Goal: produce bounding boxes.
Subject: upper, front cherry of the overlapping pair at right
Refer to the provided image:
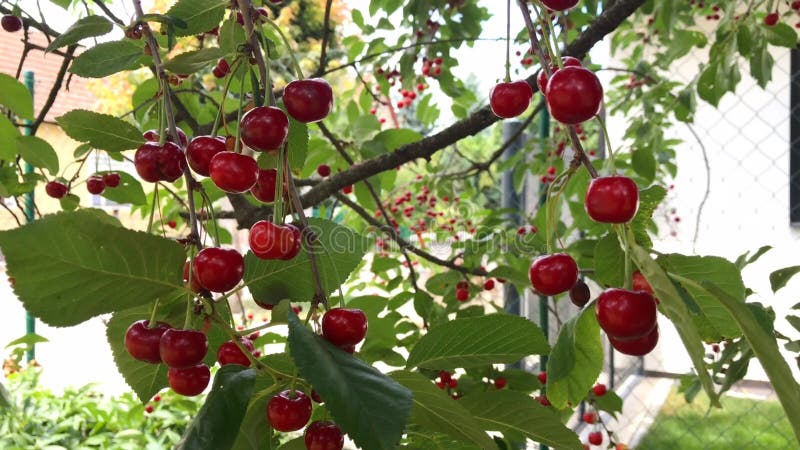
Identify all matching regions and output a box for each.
[595,288,657,340]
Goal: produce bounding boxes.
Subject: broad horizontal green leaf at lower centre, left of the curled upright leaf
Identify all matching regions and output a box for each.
[407,314,550,369]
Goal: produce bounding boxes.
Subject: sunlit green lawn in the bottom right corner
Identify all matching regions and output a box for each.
[636,390,800,450]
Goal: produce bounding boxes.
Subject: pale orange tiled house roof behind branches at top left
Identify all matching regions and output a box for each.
[0,29,97,122]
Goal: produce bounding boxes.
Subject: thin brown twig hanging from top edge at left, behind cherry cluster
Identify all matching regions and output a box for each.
[133,0,202,248]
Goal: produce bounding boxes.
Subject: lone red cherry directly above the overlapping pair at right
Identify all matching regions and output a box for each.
[585,176,639,223]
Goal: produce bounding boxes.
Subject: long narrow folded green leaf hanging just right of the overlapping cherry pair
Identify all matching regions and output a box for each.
[631,245,721,407]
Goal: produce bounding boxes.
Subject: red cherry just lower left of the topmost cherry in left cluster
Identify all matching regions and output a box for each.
[240,106,289,152]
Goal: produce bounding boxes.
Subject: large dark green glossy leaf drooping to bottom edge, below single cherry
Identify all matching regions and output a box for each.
[289,312,412,450]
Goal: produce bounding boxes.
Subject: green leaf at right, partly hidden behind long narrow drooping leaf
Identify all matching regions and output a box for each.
[658,254,745,341]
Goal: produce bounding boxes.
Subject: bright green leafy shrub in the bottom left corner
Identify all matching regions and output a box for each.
[0,369,203,450]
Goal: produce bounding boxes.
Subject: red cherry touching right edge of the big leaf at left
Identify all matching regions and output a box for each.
[192,247,244,292]
